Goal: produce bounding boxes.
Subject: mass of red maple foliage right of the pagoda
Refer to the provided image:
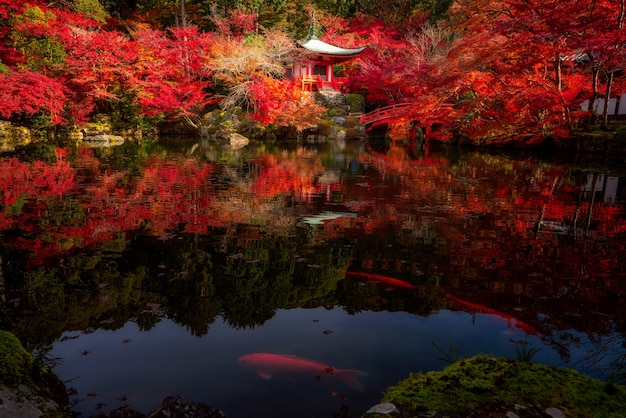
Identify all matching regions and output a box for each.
[325,0,624,143]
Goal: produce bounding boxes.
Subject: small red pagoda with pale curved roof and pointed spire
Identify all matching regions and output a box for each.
[291,10,367,91]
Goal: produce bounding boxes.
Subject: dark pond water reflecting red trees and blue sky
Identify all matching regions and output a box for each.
[0,139,626,418]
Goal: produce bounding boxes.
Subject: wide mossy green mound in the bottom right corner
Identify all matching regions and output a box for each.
[384,355,626,417]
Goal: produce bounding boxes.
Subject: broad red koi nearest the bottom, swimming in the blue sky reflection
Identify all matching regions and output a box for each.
[239,353,367,390]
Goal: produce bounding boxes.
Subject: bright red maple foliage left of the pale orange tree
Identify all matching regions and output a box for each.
[0,1,221,124]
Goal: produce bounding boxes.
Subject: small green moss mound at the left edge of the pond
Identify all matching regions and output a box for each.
[0,330,33,387]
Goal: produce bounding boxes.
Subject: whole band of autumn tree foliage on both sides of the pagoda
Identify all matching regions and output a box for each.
[0,0,626,143]
